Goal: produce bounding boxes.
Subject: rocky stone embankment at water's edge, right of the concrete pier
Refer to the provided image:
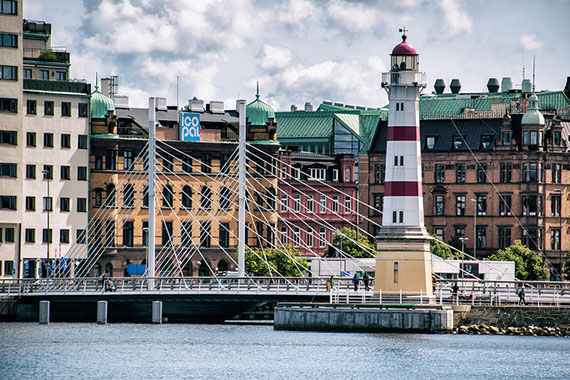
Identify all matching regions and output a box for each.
[457,306,570,328]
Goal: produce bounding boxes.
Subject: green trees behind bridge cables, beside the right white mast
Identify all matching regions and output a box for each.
[245,245,309,277]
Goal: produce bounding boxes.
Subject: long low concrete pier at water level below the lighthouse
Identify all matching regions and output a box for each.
[274,304,453,332]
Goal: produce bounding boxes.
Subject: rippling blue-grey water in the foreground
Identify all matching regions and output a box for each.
[0,323,570,380]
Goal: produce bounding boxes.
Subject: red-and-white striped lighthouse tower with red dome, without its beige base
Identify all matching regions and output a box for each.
[381,30,426,235]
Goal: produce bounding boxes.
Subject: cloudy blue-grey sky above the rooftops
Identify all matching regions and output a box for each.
[24,0,570,110]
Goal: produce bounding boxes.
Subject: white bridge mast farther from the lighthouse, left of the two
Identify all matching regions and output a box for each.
[143,98,156,290]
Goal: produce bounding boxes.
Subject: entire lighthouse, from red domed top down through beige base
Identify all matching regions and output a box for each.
[375,29,432,296]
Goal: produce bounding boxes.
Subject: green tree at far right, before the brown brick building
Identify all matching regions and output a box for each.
[487,240,548,281]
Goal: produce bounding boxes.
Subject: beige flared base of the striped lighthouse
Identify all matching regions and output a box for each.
[374,226,433,297]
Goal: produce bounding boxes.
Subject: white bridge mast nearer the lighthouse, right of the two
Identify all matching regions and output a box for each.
[236,99,247,277]
